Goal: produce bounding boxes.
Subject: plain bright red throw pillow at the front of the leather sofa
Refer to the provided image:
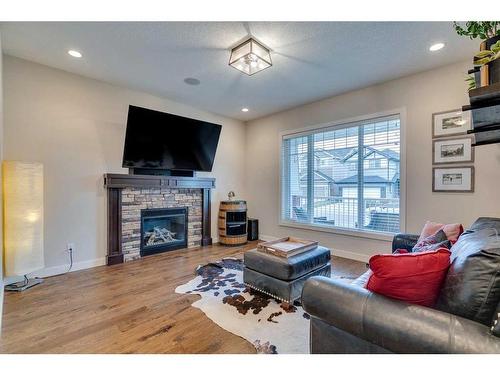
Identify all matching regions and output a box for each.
[366,248,451,307]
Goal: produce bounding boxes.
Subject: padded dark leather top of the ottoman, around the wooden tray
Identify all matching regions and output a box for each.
[243,246,330,280]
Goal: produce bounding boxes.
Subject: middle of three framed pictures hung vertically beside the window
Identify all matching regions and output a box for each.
[432,137,474,164]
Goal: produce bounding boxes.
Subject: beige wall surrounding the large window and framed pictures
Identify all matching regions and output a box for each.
[246,62,500,259]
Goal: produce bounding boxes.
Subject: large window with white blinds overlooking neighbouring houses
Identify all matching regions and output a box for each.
[281,115,401,233]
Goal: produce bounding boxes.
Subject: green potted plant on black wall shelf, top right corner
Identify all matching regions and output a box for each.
[453,21,500,87]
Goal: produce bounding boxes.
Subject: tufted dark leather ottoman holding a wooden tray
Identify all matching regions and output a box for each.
[243,246,331,303]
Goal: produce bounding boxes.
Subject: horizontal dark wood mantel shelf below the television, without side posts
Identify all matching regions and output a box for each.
[104,173,215,189]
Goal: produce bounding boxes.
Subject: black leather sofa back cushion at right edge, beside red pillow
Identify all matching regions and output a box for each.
[437,219,500,325]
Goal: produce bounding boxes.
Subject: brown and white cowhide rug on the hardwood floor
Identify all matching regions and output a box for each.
[175,258,352,354]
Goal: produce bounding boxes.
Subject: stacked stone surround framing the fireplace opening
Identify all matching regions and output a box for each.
[121,188,202,262]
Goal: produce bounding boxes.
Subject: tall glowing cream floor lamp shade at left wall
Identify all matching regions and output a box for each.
[3,161,44,276]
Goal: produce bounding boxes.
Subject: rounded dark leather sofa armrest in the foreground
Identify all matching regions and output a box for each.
[302,277,500,353]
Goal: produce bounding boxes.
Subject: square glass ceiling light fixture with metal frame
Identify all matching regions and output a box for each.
[229,38,273,76]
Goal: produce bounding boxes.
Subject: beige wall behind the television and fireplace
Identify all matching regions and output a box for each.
[4,56,245,274]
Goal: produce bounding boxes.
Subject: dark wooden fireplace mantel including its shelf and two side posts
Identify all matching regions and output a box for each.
[104,173,215,266]
